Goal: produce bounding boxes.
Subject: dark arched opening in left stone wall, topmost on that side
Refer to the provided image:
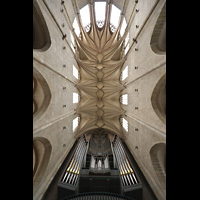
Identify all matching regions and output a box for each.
[33,1,51,51]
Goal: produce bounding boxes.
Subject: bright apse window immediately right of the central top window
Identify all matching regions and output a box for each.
[110,5,121,32]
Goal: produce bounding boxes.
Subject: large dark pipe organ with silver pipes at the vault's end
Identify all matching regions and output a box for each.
[58,129,142,200]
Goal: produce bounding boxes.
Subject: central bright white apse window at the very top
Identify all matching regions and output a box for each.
[94,2,106,28]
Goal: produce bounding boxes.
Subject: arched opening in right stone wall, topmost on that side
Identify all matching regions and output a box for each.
[150,4,166,54]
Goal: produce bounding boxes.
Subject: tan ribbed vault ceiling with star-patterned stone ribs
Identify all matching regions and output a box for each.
[73,1,130,135]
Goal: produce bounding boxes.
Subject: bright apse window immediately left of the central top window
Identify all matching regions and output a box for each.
[80,5,90,32]
